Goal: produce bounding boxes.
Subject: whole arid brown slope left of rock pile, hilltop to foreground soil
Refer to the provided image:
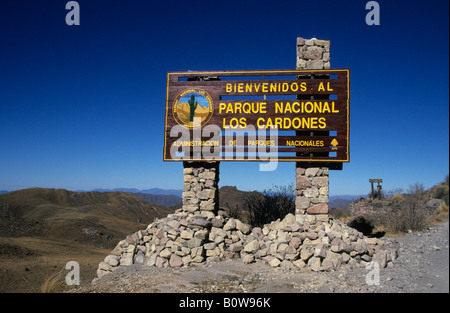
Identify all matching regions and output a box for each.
[0,188,172,292]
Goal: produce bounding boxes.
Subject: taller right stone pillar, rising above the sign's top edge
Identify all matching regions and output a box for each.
[295,37,330,220]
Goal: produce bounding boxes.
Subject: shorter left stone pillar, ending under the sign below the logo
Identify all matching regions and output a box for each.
[182,161,220,220]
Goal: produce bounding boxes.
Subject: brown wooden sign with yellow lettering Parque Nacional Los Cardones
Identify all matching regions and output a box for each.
[164,69,350,162]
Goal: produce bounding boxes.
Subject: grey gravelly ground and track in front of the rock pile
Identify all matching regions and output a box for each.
[72,221,449,293]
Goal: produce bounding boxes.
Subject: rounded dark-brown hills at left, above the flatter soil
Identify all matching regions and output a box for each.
[0,188,170,244]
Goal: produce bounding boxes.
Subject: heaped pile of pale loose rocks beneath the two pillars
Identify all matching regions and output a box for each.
[97,209,397,277]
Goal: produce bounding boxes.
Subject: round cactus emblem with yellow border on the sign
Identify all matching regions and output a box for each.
[173,88,214,128]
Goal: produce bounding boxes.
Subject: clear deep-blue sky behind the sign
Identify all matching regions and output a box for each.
[0,0,449,195]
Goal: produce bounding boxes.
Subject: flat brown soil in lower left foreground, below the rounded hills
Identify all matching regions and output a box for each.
[0,237,110,292]
